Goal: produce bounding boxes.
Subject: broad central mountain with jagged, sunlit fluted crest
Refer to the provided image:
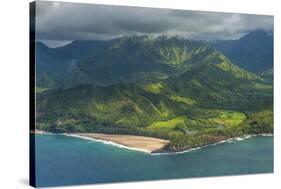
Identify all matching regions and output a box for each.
[62,36,214,87]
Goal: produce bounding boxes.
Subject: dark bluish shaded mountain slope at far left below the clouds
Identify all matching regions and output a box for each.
[35,41,110,89]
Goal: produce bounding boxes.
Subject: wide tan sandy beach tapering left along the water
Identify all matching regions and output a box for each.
[73,133,169,152]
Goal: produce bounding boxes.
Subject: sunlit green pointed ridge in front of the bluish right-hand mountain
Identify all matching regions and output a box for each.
[165,52,272,110]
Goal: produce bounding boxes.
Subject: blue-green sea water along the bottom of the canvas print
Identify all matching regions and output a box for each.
[35,135,273,187]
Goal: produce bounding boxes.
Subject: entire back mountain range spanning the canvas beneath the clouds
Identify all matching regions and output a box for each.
[36,30,273,88]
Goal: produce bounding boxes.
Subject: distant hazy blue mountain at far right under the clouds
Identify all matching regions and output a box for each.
[214,30,273,73]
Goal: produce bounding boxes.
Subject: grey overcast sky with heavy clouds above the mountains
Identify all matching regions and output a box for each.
[36,1,273,46]
